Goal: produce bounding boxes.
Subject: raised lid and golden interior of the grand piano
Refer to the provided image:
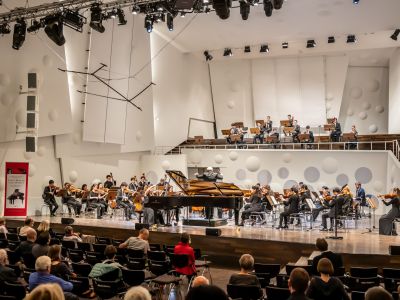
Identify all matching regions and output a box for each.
[165,170,243,196]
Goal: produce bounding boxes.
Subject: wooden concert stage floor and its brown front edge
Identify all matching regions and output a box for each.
[7,216,400,268]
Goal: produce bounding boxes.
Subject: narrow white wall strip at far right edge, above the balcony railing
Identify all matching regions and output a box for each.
[389,48,400,133]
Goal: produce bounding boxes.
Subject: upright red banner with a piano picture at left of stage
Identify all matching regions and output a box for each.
[4,162,29,217]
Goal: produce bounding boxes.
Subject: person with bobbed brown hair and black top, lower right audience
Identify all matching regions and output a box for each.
[307,258,350,300]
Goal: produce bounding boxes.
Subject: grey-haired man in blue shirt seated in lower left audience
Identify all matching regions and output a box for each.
[29,256,73,292]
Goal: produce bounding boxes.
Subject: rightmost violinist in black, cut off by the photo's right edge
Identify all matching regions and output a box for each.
[378,188,400,235]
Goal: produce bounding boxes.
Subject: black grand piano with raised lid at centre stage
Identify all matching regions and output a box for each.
[145,170,244,226]
